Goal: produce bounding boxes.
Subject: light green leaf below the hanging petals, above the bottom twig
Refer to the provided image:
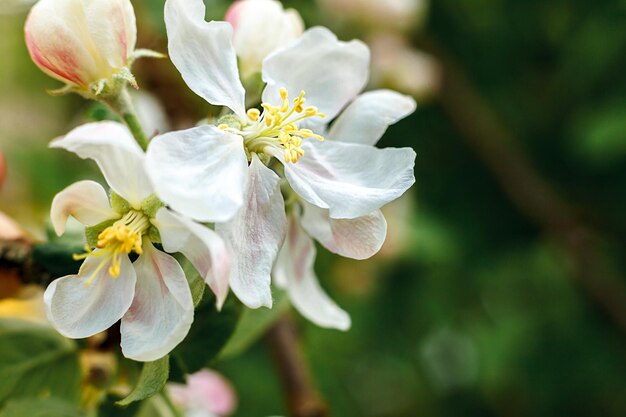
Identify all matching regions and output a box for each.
[219,291,289,359]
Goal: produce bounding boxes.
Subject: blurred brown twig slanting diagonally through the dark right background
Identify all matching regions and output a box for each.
[426,40,626,332]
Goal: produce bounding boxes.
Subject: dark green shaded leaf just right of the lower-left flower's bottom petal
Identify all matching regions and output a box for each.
[172,290,243,373]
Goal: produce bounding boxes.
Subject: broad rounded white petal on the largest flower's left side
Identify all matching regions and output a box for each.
[146,125,248,222]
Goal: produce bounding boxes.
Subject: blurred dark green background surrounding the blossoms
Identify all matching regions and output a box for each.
[0,0,626,417]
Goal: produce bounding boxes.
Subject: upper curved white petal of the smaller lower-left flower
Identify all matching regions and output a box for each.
[50,122,153,208]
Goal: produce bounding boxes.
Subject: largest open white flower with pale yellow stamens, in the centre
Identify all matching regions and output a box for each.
[147,0,415,328]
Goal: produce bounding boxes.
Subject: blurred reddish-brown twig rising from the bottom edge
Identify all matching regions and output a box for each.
[267,315,330,417]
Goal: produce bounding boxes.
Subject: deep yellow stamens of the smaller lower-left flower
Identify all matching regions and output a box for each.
[74,210,150,287]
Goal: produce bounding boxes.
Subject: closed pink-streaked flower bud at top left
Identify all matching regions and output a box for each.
[25,0,137,89]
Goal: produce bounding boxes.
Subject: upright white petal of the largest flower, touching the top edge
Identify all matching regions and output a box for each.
[165,0,245,115]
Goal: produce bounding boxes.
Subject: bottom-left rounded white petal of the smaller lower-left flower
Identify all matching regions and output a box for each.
[44,250,137,339]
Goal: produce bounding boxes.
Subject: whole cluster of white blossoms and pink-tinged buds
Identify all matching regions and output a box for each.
[26,0,416,361]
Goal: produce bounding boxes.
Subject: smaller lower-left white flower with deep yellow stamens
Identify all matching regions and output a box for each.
[44,122,229,361]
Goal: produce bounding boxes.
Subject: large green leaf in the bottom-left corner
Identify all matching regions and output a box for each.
[0,319,81,403]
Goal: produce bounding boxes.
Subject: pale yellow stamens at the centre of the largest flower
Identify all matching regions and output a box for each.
[218,88,326,163]
